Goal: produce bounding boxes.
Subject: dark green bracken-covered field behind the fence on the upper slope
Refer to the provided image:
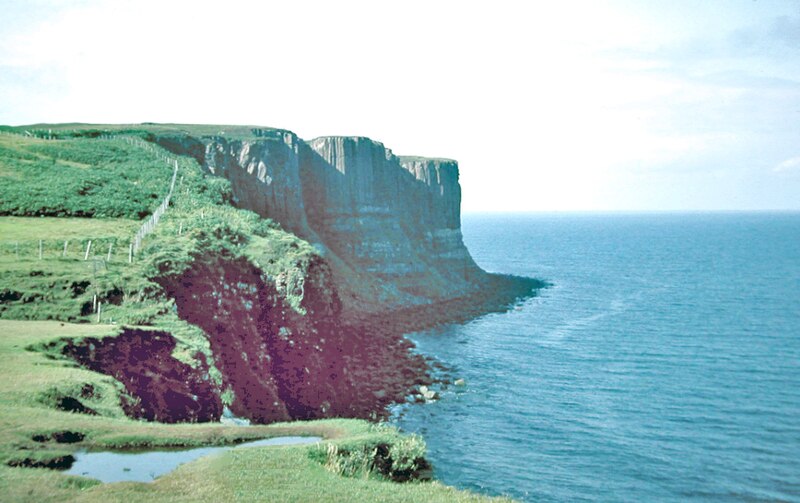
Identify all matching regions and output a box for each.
[0,134,178,219]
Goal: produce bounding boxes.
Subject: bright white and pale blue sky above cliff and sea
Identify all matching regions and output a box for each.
[0,0,800,212]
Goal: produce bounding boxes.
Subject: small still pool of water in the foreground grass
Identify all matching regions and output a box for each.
[64,437,322,482]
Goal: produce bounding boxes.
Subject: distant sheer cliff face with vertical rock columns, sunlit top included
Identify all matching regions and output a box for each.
[156,130,486,315]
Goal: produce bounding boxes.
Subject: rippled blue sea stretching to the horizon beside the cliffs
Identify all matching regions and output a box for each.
[395,213,800,501]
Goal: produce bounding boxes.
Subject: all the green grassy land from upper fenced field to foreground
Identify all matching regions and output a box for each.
[0,129,510,501]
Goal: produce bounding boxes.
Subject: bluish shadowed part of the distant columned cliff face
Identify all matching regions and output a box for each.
[299,138,486,316]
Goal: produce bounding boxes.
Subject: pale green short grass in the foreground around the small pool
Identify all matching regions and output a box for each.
[0,320,510,502]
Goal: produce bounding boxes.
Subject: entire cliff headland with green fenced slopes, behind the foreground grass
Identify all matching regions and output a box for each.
[0,125,542,423]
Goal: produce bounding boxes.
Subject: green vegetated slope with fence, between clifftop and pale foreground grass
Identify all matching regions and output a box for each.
[0,134,315,366]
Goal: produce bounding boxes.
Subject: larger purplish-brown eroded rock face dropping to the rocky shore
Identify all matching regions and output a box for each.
[155,257,432,423]
